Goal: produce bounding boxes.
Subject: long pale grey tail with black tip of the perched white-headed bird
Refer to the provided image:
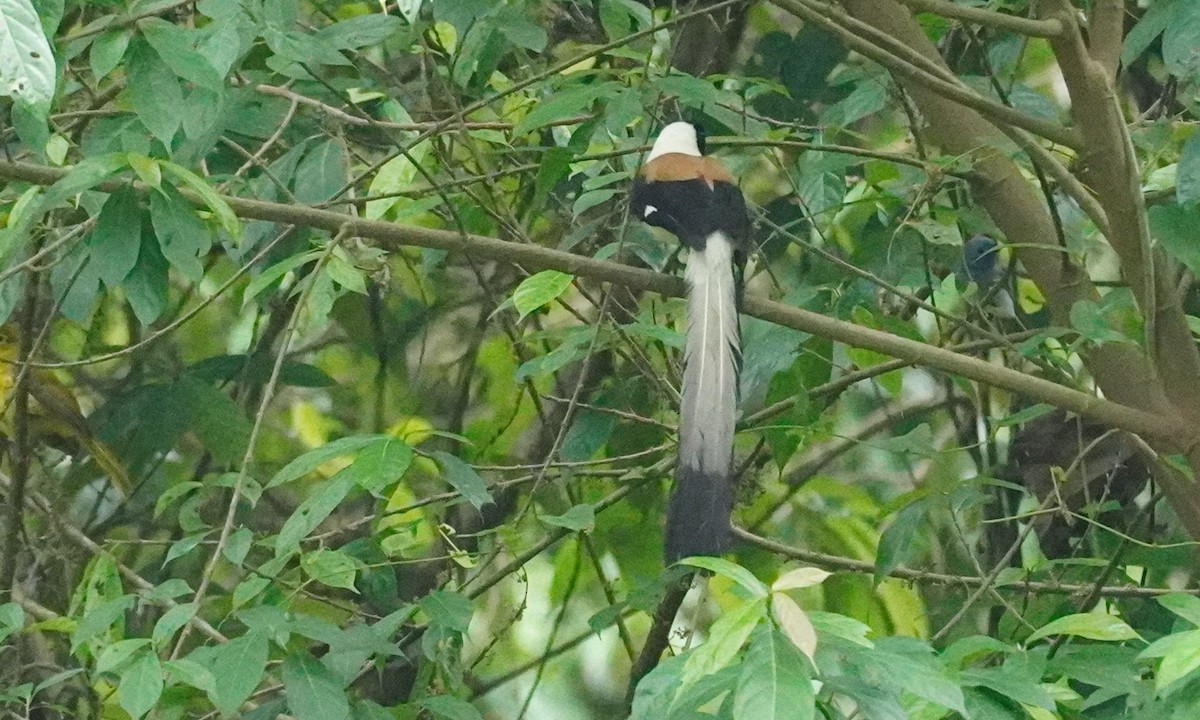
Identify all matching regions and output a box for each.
[665,233,740,562]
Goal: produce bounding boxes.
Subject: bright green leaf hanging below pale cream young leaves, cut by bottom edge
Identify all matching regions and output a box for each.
[733,625,816,720]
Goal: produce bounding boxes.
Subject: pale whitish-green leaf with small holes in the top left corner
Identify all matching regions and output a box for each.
[0,0,58,104]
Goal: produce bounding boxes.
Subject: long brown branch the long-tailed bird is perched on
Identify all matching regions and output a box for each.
[0,162,1193,448]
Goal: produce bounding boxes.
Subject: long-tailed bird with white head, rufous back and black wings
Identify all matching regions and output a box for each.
[630,121,750,563]
